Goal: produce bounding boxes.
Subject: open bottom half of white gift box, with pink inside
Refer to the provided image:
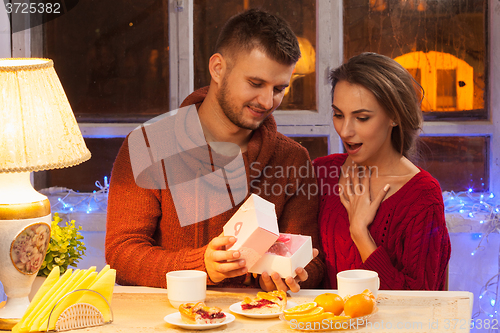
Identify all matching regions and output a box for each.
[249,234,313,278]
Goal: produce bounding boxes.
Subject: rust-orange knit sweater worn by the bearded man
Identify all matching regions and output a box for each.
[106,89,324,288]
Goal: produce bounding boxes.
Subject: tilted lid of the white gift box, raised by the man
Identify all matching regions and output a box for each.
[224,194,279,268]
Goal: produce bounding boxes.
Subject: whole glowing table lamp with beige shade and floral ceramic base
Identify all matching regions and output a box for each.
[0,58,90,329]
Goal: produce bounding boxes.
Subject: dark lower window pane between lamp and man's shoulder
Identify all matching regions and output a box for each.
[35,138,125,192]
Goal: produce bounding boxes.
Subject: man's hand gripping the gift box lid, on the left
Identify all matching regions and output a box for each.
[205,234,248,283]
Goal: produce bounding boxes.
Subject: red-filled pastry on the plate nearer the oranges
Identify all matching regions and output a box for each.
[241,290,286,314]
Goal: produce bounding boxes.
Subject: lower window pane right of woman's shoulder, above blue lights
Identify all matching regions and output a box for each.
[417,136,489,192]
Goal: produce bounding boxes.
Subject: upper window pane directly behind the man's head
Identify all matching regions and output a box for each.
[194,0,316,110]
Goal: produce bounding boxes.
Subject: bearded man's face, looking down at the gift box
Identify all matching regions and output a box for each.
[216,49,295,130]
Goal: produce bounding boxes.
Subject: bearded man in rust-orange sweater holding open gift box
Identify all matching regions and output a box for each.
[106,9,324,292]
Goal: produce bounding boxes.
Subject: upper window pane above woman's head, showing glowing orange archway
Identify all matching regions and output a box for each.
[344,0,487,120]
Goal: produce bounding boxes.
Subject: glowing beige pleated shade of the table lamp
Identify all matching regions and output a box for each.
[0,58,90,172]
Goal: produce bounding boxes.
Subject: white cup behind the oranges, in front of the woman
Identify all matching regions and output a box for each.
[337,269,380,298]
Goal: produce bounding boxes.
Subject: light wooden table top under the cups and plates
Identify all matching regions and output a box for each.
[72,286,473,333]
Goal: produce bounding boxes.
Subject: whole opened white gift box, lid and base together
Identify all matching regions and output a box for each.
[224,194,313,278]
